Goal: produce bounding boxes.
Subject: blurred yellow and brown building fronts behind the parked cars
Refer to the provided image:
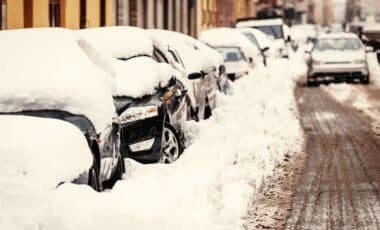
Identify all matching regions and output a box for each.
[0,0,257,36]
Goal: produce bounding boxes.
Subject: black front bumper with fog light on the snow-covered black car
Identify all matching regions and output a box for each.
[120,116,163,163]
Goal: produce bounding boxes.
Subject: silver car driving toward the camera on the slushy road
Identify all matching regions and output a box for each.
[307,33,370,85]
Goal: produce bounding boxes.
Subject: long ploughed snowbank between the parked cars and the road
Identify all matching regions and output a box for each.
[0,53,305,230]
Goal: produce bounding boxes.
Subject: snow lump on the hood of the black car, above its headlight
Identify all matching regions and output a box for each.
[114,56,180,98]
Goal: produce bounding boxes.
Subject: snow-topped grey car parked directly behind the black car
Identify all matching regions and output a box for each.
[149,30,221,119]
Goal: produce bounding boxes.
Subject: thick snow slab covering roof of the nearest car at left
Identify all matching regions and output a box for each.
[0,28,115,131]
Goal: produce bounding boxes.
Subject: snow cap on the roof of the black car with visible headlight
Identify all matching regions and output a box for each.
[77,26,153,58]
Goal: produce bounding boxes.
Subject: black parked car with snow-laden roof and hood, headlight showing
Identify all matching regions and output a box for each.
[77,27,188,163]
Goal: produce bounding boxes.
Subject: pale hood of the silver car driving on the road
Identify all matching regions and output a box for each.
[311,50,366,62]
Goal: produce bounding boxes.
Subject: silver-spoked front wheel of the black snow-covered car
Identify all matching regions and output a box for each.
[159,124,182,164]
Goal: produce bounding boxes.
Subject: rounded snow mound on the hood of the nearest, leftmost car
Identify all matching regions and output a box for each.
[0,115,92,191]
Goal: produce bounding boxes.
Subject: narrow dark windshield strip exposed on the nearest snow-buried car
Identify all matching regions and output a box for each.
[0,110,96,136]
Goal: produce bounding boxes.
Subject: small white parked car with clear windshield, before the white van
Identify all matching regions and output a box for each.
[214,46,250,81]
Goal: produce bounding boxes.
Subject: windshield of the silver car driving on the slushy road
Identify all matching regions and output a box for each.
[314,38,362,51]
